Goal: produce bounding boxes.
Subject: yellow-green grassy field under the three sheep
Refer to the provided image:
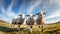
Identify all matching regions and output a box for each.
[0,21,60,34]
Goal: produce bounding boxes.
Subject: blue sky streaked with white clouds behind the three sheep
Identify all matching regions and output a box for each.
[0,0,60,24]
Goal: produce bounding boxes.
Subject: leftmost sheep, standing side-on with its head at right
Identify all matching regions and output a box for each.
[11,15,25,30]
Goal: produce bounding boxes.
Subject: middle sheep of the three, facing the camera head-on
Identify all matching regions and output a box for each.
[26,14,35,33]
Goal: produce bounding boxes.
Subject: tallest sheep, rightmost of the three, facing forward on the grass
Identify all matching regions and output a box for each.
[36,11,45,31]
